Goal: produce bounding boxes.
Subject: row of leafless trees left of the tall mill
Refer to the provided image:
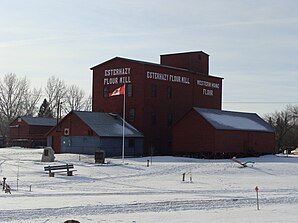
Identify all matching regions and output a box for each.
[0,74,91,144]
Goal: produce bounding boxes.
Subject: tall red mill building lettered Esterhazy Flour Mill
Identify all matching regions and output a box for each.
[91,51,222,155]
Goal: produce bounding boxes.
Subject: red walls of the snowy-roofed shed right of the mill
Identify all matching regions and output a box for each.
[173,109,274,158]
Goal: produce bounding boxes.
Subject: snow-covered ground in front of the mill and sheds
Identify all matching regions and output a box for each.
[0,148,298,223]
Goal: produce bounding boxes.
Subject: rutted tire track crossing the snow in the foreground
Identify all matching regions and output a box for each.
[0,197,298,222]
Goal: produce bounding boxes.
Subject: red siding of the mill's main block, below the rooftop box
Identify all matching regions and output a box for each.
[92,54,222,155]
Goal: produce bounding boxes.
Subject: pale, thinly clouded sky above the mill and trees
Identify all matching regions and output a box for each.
[0,0,298,115]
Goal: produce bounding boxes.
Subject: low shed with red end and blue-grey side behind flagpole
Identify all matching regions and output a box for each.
[47,111,144,157]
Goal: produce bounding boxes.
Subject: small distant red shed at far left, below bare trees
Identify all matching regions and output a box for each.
[9,116,57,147]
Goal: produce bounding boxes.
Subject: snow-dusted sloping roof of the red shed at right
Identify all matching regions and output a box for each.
[194,108,274,132]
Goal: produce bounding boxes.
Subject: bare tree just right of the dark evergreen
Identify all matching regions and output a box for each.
[45,76,67,117]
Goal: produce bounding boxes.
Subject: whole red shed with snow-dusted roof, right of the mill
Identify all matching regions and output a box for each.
[173,108,275,158]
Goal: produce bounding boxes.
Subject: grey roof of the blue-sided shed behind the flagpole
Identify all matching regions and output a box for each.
[73,111,144,137]
